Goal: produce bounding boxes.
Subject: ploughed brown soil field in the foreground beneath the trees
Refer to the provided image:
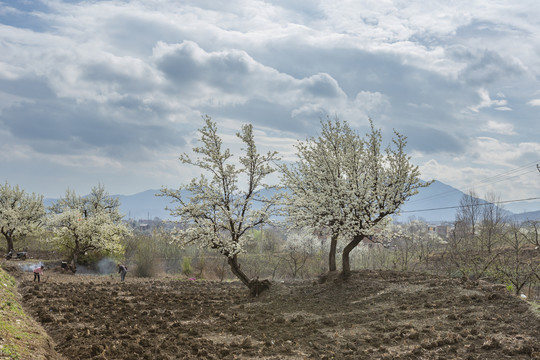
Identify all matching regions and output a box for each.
[8,271,540,360]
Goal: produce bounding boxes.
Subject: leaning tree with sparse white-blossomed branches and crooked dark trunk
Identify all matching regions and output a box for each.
[161,116,279,294]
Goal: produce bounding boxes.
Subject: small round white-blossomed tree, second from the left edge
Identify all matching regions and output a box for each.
[49,185,130,272]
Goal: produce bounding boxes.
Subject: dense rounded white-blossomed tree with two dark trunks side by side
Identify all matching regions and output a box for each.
[282,118,429,278]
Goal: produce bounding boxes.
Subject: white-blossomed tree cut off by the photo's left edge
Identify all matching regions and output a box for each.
[0,182,45,252]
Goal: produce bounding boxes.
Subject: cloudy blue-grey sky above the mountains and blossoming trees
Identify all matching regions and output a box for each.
[0,0,540,212]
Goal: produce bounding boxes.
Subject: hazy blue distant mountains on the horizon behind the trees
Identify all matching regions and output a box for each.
[44,181,540,223]
